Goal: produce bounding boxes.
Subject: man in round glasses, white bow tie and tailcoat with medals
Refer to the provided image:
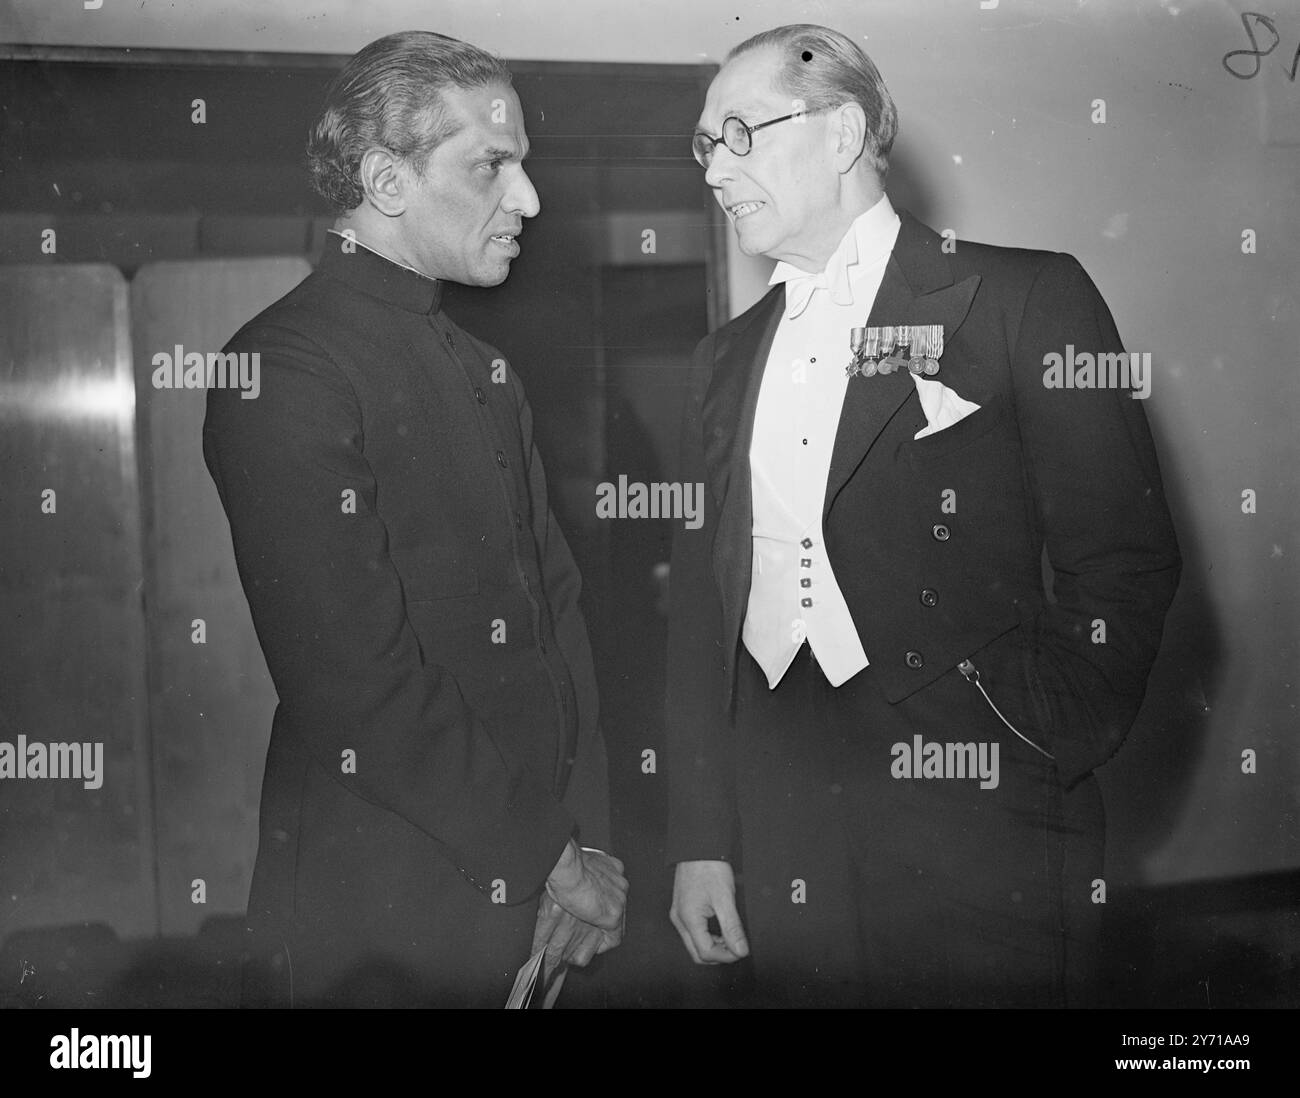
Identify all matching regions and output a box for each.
[667,25,1180,1007]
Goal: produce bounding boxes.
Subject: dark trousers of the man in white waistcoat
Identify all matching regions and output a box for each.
[736,645,1104,1007]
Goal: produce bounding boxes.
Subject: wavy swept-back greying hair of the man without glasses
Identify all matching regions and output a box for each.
[307,30,511,211]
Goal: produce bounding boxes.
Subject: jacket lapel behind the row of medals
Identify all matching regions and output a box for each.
[822,211,980,525]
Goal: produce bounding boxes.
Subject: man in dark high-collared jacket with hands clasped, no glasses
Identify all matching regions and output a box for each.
[203,31,627,1007]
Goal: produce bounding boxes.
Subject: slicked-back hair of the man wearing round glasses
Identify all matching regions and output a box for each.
[727,23,898,178]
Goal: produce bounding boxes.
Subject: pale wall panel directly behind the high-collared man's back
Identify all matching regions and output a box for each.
[131,259,311,934]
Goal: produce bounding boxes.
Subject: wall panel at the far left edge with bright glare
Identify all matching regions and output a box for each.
[0,265,157,941]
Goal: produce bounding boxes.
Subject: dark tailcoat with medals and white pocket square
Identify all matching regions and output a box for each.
[667,213,1180,862]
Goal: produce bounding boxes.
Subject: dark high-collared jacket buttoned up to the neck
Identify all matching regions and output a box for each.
[203,236,608,1002]
